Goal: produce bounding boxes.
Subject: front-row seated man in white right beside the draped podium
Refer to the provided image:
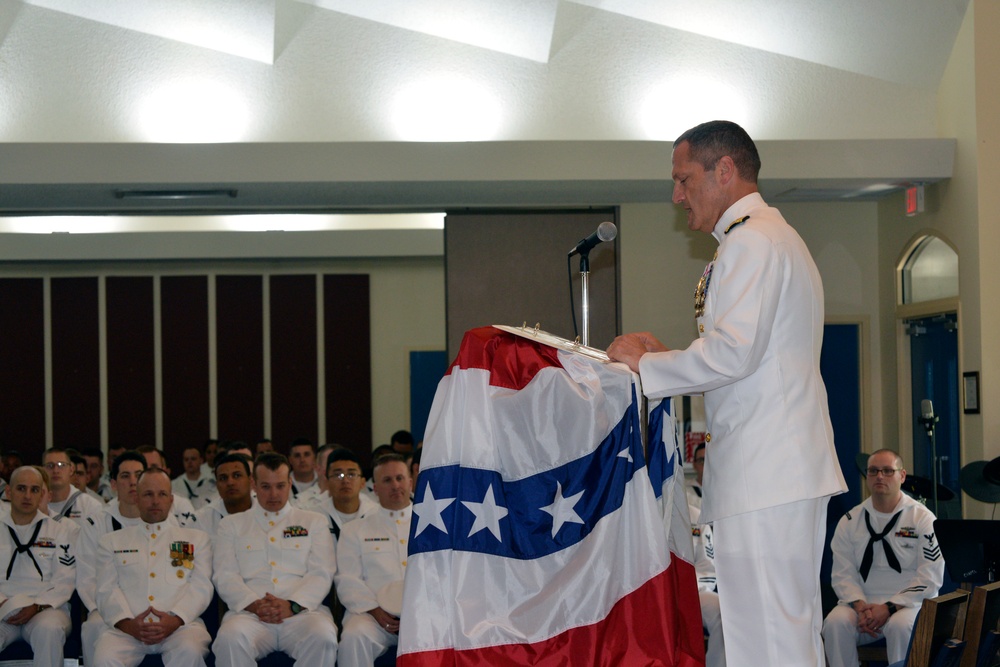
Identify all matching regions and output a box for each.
[336,454,413,667]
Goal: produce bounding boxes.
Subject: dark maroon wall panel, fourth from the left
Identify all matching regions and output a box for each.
[160,275,211,476]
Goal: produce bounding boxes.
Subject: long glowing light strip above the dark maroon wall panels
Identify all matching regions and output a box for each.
[0,213,445,234]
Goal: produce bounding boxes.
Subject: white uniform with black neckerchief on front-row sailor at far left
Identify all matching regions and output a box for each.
[0,512,80,666]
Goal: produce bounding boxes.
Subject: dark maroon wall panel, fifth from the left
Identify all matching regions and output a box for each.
[215,275,268,442]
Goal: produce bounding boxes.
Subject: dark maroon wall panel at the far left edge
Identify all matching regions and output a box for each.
[0,278,45,461]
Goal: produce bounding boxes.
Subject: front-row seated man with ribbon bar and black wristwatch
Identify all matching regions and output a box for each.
[212,453,337,667]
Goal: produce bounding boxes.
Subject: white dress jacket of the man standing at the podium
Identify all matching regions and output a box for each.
[639,193,847,523]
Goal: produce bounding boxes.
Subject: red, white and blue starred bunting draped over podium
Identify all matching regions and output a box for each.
[397,327,704,667]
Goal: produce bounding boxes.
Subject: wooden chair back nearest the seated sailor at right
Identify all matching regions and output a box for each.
[893,590,969,667]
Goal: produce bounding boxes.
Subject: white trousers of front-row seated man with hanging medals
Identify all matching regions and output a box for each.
[92,619,212,667]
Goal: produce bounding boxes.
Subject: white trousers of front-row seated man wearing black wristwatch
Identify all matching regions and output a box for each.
[212,607,337,667]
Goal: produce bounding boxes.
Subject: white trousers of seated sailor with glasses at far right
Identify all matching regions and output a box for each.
[823,604,920,667]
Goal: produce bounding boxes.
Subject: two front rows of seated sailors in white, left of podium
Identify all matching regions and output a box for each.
[0,448,413,667]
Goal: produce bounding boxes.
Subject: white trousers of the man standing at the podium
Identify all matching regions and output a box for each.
[714,497,829,667]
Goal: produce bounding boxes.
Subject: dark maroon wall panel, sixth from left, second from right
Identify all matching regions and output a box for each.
[270,274,322,451]
